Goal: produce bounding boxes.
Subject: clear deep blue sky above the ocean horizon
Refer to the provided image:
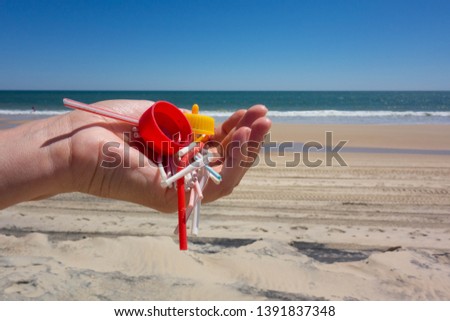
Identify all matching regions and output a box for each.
[0,0,450,90]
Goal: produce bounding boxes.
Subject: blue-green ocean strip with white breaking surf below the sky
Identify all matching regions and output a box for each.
[0,91,450,124]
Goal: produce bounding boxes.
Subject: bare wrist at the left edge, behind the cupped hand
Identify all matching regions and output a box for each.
[0,115,72,208]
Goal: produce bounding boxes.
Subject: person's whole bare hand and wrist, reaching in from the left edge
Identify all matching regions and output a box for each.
[0,100,271,212]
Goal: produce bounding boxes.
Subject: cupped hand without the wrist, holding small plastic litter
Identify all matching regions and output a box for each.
[69,100,270,212]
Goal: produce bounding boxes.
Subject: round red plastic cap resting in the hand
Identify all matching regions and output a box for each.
[138,101,192,156]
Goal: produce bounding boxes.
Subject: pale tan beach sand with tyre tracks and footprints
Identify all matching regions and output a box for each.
[0,124,450,300]
